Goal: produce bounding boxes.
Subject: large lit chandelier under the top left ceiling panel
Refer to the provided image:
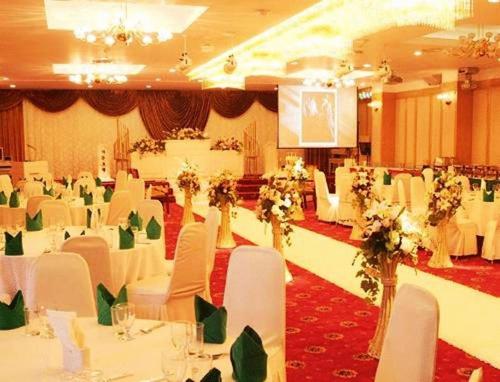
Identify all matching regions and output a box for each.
[74,1,172,46]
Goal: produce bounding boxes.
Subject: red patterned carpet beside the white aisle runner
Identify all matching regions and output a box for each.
[166,205,500,382]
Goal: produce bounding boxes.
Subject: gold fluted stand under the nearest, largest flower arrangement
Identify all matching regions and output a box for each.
[368,258,399,358]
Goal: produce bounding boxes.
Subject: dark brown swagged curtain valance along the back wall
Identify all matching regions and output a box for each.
[0,90,278,139]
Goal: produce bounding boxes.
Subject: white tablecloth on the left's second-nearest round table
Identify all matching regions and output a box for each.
[0,226,167,305]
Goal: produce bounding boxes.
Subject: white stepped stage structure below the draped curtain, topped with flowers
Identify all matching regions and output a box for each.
[131,139,244,181]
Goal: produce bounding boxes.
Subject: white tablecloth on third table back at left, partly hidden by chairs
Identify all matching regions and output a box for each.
[0,198,109,227]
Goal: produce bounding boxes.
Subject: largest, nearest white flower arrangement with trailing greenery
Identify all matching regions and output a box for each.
[354,200,424,302]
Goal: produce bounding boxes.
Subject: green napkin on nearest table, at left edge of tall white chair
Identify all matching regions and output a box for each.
[194,296,227,344]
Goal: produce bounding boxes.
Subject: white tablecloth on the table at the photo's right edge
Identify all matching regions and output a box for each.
[462,191,500,236]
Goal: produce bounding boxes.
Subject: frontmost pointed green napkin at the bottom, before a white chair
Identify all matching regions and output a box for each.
[231,325,267,382]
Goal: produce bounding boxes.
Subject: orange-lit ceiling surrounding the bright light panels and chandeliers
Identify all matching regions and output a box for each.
[0,0,500,89]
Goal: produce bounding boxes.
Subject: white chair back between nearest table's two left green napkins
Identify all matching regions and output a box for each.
[28,253,96,317]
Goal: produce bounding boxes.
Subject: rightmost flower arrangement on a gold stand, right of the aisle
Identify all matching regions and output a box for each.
[427,171,462,226]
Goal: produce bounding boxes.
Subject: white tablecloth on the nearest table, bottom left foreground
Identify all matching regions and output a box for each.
[0,318,233,382]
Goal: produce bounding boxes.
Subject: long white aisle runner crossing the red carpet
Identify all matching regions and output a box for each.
[182,195,500,368]
